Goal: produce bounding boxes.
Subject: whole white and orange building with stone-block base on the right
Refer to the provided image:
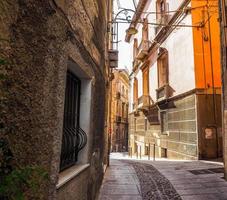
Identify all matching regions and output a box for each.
[126,0,222,159]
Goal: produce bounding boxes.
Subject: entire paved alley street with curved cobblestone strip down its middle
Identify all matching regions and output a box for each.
[99,154,227,200]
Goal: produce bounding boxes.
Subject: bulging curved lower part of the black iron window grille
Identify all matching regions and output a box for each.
[60,127,87,171]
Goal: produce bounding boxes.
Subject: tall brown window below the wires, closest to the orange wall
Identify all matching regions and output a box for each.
[157,48,169,88]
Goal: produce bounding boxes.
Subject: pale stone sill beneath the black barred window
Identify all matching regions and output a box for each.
[56,164,90,189]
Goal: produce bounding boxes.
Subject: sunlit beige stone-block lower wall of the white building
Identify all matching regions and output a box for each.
[130,95,198,159]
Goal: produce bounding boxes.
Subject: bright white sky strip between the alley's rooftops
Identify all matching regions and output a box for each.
[114,0,134,71]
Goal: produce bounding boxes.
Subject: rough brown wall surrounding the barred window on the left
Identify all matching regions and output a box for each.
[0,0,110,199]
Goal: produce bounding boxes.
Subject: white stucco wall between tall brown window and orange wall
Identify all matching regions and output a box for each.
[162,15,195,95]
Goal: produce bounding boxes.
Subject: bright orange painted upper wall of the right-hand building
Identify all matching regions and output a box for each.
[191,0,221,89]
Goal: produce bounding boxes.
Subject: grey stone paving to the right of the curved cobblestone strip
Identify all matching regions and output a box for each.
[141,161,227,200]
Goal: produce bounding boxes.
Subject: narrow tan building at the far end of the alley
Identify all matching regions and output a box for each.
[111,69,129,152]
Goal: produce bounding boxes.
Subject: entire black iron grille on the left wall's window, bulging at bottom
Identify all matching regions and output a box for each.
[60,71,87,171]
